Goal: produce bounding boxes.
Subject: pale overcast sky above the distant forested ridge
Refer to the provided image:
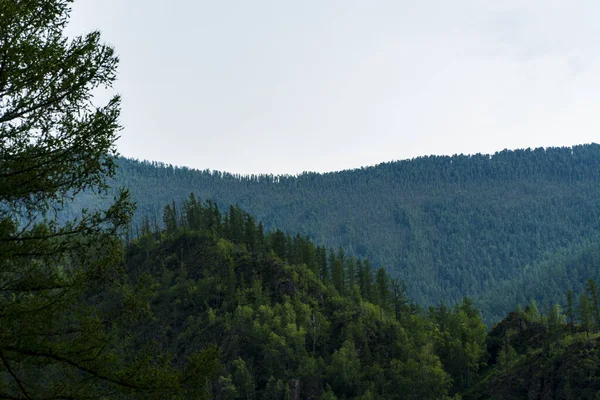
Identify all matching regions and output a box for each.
[67,0,600,174]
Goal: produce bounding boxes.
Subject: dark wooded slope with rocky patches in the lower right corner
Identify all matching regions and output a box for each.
[472,280,600,399]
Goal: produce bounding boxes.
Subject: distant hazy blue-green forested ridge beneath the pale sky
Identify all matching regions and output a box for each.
[76,144,600,320]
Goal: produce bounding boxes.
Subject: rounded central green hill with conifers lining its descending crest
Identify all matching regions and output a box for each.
[126,200,485,399]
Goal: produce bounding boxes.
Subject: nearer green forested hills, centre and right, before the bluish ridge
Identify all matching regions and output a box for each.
[115,195,600,400]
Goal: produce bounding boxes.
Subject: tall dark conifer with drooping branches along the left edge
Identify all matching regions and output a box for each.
[0,0,216,399]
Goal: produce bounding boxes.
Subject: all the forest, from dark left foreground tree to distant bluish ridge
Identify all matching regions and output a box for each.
[0,0,600,400]
